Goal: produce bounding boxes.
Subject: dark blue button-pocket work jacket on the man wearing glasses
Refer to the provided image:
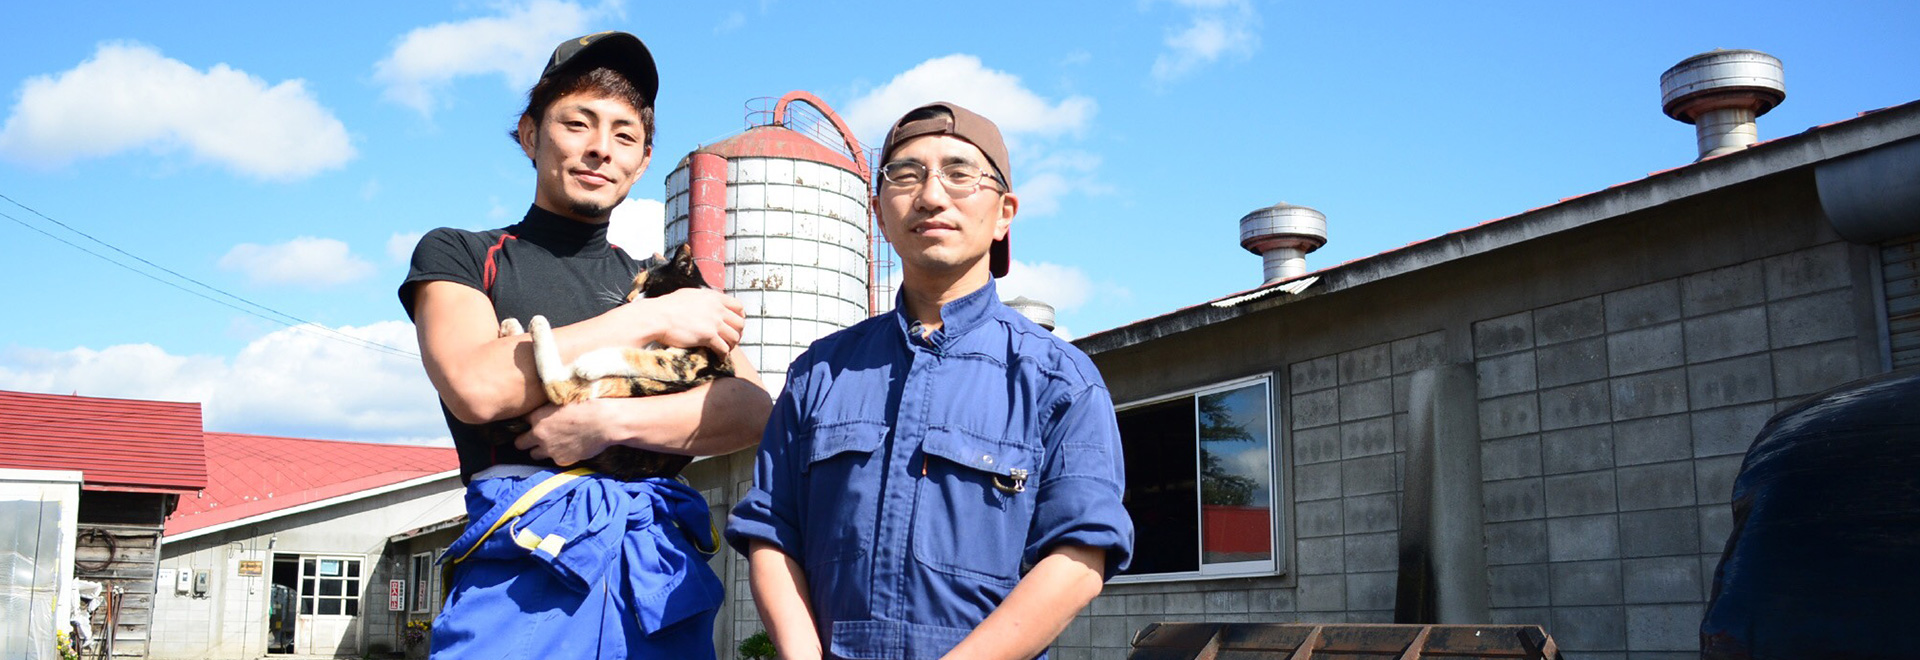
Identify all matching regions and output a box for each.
[726,282,1133,658]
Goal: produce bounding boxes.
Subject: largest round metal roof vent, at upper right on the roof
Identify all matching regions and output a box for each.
[1661,50,1788,159]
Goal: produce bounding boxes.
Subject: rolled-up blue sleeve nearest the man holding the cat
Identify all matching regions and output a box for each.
[726,363,806,562]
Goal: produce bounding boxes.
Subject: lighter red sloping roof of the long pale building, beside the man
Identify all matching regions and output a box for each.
[165,434,459,537]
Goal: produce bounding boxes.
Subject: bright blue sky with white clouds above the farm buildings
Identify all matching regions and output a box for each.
[0,0,1920,441]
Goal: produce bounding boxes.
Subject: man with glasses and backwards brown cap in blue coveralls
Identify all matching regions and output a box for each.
[726,104,1133,660]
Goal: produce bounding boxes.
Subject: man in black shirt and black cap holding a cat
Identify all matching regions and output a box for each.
[399,33,772,658]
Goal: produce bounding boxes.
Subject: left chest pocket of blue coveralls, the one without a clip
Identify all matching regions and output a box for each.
[803,422,887,566]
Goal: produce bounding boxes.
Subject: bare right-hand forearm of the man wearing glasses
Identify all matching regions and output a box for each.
[947,545,1106,660]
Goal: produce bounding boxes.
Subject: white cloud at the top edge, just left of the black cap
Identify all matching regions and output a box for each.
[372,0,620,115]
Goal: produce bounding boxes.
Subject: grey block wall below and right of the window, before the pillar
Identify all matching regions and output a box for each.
[1050,332,1446,660]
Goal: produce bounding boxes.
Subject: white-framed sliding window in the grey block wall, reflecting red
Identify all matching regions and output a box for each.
[1117,378,1277,578]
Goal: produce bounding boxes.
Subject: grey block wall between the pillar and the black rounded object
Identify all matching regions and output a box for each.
[1473,244,1864,658]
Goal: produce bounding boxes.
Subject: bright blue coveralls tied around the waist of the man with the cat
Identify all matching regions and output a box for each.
[432,468,722,660]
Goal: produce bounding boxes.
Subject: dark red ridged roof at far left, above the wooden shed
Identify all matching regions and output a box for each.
[0,391,207,493]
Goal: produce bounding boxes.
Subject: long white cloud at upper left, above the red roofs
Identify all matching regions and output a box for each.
[0,42,353,180]
